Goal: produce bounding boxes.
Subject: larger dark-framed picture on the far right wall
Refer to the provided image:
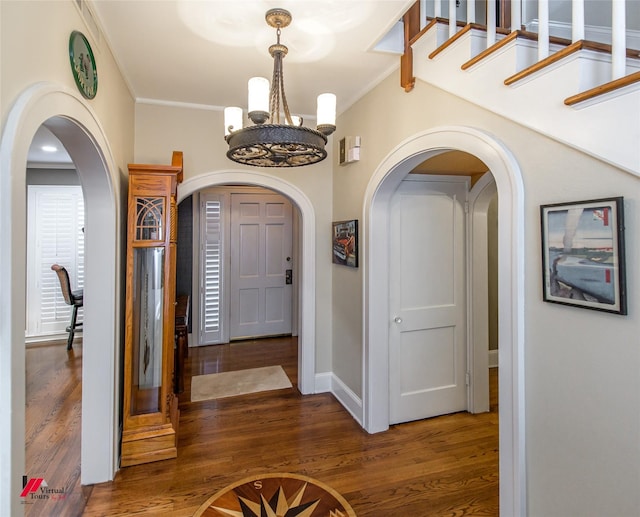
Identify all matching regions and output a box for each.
[540,197,627,314]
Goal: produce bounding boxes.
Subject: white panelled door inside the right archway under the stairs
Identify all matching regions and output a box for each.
[389,176,468,424]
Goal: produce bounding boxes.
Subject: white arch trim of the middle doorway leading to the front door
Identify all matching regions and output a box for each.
[178,171,316,394]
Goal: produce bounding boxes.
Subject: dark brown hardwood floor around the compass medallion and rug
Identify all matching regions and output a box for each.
[27,338,498,517]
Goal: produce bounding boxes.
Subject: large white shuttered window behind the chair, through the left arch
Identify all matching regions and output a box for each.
[26,185,84,337]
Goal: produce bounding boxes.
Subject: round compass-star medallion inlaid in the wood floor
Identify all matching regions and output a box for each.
[193,474,356,517]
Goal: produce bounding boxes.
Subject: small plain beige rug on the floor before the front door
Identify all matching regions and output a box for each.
[191,366,291,402]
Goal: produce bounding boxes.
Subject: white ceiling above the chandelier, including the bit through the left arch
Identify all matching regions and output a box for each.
[29,0,414,165]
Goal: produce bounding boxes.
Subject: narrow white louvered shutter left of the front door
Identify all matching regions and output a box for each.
[199,194,222,345]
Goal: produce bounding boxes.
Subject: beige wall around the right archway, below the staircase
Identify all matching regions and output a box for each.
[333,74,640,517]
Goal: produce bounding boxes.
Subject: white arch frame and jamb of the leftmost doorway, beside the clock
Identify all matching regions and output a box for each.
[0,83,122,515]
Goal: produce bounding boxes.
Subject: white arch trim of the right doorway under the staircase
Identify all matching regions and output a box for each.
[363,127,526,515]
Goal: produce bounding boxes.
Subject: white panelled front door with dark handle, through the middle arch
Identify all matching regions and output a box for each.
[229,194,293,339]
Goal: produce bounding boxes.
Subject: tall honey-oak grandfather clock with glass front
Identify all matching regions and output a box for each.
[121,151,182,467]
